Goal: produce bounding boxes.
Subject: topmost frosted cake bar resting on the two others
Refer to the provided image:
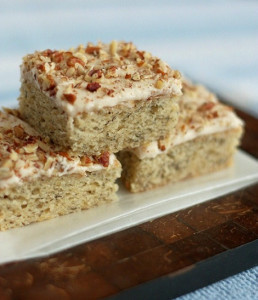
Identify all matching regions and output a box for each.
[20,42,181,155]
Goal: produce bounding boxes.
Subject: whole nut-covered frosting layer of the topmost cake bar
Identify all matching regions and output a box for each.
[21,41,181,116]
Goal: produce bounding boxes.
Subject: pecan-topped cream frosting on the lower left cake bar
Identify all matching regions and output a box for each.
[0,110,118,189]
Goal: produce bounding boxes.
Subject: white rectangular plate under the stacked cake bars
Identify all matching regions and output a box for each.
[0,151,258,263]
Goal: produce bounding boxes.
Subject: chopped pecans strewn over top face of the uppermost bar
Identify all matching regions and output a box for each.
[24,41,183,106]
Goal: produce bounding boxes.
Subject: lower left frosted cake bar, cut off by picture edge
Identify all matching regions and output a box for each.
[0,110,121,230]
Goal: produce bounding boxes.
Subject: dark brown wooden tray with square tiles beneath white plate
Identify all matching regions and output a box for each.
[0,111,258,300]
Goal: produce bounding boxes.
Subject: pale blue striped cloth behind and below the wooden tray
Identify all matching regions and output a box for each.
[0,0,258,300]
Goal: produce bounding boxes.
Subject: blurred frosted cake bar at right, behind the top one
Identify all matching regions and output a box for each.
[118,80,243,192]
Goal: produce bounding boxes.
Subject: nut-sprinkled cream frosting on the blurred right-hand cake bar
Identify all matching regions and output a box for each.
[130,80,243,159]
